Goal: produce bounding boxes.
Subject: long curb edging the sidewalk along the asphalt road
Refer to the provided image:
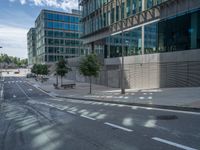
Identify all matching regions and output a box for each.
[55,96,200,112]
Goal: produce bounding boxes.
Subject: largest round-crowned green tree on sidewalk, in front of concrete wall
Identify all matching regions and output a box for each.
[79,54,100,94]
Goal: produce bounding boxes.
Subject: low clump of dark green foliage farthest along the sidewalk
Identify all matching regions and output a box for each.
[31,64,49,75]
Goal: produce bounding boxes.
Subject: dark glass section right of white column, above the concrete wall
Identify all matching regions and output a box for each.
[145,11,200,54]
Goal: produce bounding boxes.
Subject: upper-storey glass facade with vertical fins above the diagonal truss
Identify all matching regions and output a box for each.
[81,0,167,36]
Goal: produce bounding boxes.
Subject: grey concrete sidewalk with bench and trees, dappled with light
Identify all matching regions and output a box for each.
[27,77,200,110]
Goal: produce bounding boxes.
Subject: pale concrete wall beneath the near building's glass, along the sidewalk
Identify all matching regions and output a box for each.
[68,50,200,89]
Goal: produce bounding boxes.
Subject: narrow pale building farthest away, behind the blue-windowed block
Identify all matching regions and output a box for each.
[27,28,36,66]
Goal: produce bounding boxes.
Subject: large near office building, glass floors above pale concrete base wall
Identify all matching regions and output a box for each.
[75,0,200,88]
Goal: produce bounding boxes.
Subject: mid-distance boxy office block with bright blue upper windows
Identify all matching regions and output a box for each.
[27,10,83,64]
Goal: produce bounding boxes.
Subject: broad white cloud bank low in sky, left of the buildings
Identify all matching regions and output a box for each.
[0,25,28,58]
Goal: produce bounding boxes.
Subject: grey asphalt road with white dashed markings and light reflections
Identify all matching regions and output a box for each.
[0,77,200,150]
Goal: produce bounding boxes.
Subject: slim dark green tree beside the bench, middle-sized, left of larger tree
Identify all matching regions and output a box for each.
[56,59,71,85]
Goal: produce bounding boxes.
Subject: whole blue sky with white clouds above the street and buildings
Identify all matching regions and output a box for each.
[0,0,78,58]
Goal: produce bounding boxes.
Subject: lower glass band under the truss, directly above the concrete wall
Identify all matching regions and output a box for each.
[106,8,200,57]
